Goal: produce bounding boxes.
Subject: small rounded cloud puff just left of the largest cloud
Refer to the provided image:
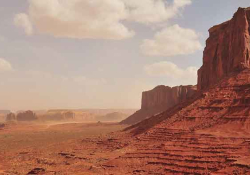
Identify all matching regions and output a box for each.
[14,13,33,35]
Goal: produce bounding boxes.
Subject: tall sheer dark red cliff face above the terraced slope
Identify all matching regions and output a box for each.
[198,8,250,90]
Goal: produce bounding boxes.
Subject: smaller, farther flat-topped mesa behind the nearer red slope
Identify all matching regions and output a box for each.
[121,85,197,124]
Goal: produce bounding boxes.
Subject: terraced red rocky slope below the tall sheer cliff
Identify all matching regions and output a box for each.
[105,50,250,175]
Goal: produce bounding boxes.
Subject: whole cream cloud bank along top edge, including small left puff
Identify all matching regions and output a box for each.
[15,0,191,40]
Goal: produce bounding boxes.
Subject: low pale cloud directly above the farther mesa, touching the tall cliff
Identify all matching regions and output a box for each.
[144,61,198,84]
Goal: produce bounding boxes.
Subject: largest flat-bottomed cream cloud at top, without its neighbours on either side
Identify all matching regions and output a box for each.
[14,0,134,39]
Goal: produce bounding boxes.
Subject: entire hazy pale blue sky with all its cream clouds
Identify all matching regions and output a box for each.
[0,0,250,110]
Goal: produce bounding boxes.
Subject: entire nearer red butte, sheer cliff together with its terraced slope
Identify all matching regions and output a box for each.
[101,8,250,175]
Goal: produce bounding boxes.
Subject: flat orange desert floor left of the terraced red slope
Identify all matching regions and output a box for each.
[0,123,125,175]
